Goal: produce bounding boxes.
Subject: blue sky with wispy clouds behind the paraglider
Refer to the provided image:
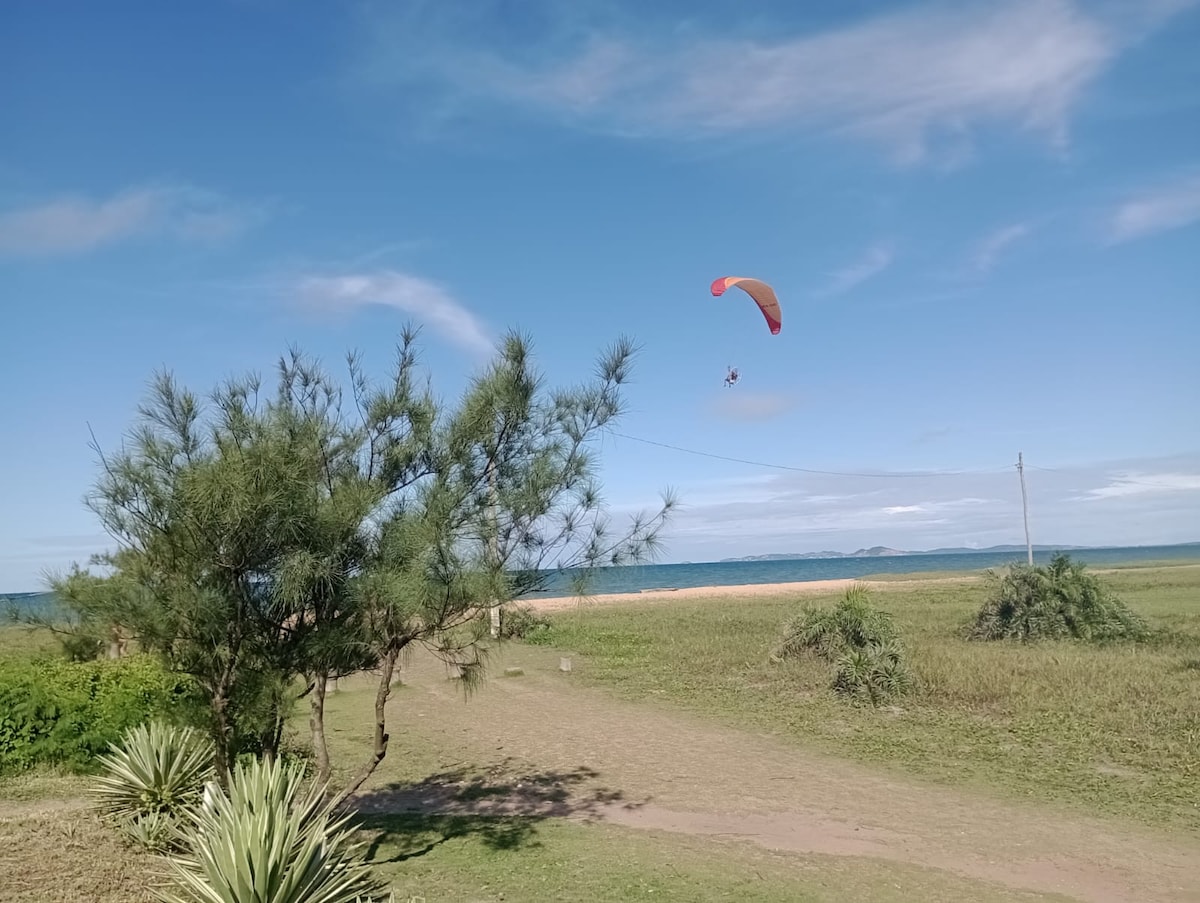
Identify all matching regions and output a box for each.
[0,0,1200,591]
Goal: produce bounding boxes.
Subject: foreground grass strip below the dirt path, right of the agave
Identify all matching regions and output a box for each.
[364,815,1066,903]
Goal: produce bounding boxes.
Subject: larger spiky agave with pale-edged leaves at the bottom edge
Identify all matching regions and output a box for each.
[158,760,383,903]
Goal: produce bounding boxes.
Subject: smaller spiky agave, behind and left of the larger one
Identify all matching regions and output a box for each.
[90,719,215,851]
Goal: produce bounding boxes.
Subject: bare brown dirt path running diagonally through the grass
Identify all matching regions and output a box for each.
[364,647,1200,903]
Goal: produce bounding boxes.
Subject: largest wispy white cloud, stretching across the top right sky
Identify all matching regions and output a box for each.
[355,0,1181,162]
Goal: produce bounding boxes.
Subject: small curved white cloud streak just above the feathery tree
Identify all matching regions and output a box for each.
[296,270,496,354]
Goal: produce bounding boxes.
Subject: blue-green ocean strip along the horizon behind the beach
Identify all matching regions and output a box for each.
[0,543,1200,617]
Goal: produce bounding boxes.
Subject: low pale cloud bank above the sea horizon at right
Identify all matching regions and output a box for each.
[614,452,1200,561]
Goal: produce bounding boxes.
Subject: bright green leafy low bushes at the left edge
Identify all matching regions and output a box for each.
[0,656,197,773]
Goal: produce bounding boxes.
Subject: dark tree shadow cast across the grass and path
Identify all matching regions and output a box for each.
[354,760,647,862]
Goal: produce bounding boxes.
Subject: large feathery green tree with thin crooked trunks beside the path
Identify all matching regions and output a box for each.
[54,329,673,783]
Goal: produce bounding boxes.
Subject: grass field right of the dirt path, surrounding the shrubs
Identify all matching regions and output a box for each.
[532,567,1200,827]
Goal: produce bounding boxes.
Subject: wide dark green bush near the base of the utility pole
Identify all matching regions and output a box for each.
[967,554,1148,641]
